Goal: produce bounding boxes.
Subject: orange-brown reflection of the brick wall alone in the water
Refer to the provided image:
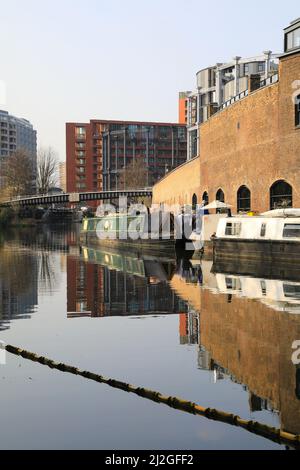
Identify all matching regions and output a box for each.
[200,290,300,434]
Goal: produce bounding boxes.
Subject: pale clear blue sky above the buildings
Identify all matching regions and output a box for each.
[0,0,300,160]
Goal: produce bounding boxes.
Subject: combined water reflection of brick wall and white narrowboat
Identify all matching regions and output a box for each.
[176,261,300,434]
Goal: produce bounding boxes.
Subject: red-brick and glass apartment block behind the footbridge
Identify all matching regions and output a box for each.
[66,120,187,192]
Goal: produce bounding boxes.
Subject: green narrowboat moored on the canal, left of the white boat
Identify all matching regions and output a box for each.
[81,213,176,256]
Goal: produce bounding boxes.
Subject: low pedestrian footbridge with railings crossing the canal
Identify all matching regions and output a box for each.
[0,188,152,207]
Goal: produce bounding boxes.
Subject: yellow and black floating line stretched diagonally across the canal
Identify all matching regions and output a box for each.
[5,345,300,448]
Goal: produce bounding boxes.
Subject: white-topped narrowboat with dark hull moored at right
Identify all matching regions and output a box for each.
[213,209,300,264]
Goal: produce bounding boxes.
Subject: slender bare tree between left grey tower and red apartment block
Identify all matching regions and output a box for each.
[37,147,58,194]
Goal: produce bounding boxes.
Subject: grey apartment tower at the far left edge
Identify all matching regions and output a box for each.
[0,110,37,187]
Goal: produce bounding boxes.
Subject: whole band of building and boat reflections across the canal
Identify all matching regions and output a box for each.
[0,227,300,444]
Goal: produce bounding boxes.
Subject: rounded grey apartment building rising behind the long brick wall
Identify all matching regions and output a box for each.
[179,51,278,160]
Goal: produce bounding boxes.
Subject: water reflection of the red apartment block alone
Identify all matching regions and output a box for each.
[67,258,187,317]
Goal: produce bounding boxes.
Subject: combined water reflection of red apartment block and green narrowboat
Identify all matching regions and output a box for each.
[67,247,188,318]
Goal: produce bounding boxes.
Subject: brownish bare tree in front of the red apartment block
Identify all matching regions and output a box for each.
[119,158,151,189]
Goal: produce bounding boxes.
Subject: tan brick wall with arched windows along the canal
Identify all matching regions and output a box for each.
[154,53,300,212]
